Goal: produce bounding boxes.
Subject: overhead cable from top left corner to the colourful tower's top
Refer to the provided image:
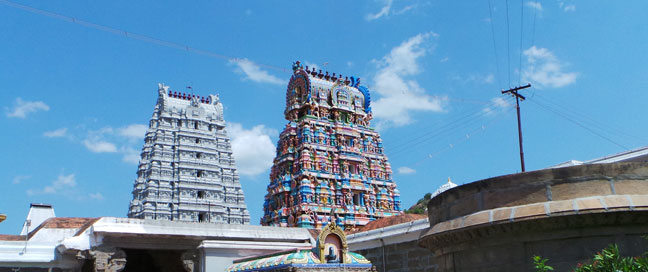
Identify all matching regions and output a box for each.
[0,0,288,73]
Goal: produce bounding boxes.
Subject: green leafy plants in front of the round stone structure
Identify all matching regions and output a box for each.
[533,244,648,272]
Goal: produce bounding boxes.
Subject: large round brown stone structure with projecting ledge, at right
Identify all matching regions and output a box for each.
[419,163,648,271]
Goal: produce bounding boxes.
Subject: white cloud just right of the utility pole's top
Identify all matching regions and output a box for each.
[522,45,578,88]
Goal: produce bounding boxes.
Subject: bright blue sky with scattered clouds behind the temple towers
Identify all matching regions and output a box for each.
[0,0,648,234]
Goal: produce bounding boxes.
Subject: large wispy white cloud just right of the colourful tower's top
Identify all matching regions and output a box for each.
[372,33,447,126]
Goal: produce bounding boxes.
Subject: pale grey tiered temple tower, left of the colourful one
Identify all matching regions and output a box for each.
[128,84,250,224]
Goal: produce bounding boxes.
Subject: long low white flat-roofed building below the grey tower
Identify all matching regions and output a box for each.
[0,217,316,272]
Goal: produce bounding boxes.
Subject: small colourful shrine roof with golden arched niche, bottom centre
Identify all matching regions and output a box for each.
[227,224,375,272]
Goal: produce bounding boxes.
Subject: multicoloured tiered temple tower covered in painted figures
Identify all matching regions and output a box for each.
[261,61,401,230]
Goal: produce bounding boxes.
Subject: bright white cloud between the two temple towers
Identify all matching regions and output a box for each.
[228,123,277,176]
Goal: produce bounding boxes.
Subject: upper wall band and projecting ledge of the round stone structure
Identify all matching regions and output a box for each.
[428,163,648,226]
